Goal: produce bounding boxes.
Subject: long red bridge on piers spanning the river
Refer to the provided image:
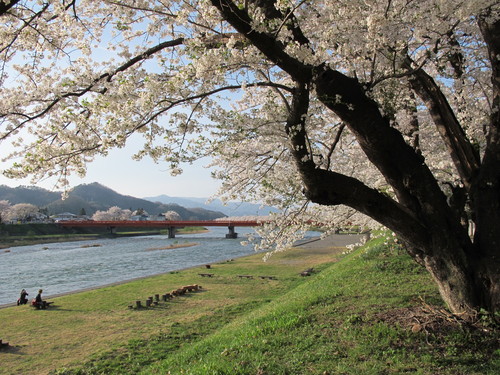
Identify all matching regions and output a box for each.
[58,219,264,238]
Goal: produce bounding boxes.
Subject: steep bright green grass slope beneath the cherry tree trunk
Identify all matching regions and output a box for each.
[51,240,500,375]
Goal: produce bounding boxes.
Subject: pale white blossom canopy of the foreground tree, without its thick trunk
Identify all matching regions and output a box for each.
[0,0,500,253]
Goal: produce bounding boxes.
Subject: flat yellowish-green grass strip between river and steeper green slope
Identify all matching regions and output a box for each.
[0,236,350,375]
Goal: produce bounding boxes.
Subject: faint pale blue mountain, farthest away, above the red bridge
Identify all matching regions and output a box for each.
[144,195,278,216]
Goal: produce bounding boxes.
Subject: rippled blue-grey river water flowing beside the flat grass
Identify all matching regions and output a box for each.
[0,228,276,305]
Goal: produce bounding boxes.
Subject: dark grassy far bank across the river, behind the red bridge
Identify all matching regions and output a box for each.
[0,224,207,249]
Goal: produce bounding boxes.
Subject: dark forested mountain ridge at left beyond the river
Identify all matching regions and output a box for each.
[0,182,225,220]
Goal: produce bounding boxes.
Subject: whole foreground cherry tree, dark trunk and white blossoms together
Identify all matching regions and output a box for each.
[0,0,500,317]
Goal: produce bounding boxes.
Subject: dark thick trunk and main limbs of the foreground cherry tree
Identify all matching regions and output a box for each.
[212,0,500,318]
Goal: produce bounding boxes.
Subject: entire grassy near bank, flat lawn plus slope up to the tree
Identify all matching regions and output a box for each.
[0,236,500,375]
